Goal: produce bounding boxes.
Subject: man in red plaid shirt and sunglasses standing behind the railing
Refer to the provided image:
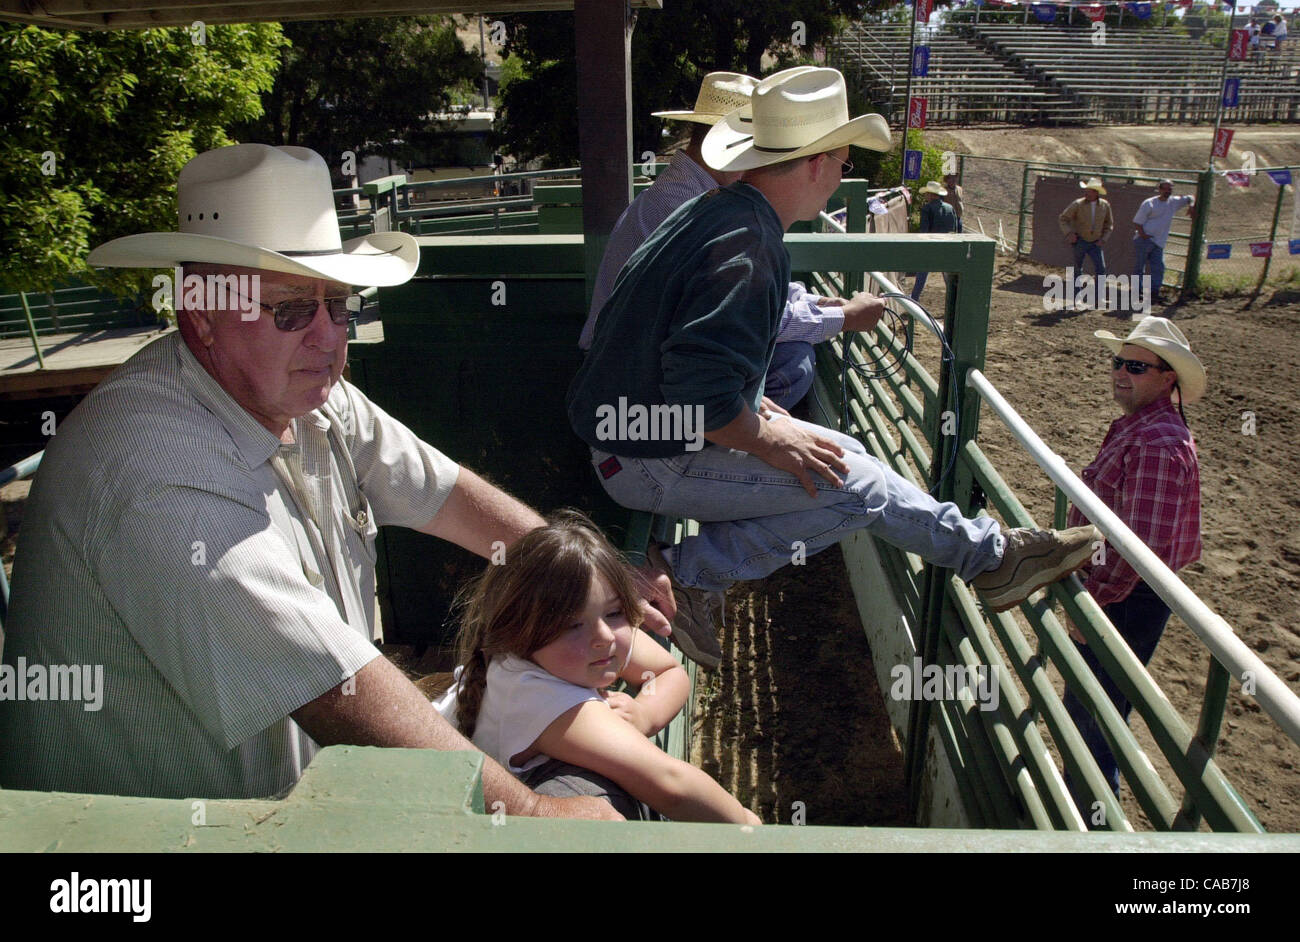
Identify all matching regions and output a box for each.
[1065,317,1205,794]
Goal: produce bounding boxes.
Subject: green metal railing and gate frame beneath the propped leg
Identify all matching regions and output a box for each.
[788,234,1295,832]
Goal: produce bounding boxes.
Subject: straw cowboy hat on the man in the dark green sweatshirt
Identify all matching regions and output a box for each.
[701,66,893,173]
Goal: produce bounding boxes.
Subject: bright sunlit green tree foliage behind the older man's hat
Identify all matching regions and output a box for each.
[0,23,282,291]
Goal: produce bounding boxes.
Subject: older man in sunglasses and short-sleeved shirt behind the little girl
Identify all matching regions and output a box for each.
[0,144,629,817]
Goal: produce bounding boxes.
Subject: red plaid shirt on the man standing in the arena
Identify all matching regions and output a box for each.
[1069,398,1201,605]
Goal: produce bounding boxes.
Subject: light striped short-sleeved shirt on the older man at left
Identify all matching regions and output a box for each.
[0,334,459,798]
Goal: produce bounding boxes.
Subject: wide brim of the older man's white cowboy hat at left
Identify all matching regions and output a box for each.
[86,233,420,287]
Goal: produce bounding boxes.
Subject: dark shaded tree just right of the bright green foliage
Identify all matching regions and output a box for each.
[237,17,482,168]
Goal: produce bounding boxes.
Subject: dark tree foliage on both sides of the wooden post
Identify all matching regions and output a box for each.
[497,0,889,166]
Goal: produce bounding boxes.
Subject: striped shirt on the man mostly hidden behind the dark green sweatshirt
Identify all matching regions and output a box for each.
[579,151,844,350]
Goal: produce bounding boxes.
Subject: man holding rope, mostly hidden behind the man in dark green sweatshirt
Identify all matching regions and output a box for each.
[579,66,881,408]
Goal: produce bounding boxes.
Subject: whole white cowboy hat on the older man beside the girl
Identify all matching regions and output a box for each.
[87,144,420,286]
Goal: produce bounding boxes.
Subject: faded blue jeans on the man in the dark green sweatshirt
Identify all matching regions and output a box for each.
[592,416,1004,591]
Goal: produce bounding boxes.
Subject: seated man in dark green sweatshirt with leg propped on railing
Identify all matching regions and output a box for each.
[568,69,1095,665]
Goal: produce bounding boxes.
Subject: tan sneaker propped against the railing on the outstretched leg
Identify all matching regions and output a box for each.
[971,526,1105,612]
